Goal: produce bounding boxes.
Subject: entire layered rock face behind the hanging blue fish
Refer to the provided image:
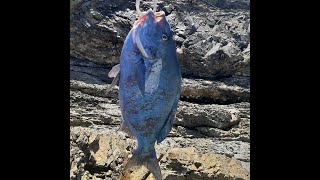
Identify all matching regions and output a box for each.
[70,0,250,180]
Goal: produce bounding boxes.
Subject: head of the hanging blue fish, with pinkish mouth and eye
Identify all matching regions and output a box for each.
[132,9,175,60]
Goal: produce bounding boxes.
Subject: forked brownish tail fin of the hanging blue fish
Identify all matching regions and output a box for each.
[124,148,162,180]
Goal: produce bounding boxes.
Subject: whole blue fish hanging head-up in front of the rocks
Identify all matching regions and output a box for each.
[108,3,181,180]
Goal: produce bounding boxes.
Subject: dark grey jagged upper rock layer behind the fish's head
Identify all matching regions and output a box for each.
[70,0,250,79]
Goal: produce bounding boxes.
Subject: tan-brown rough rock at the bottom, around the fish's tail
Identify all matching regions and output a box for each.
[70,126,249,180]
